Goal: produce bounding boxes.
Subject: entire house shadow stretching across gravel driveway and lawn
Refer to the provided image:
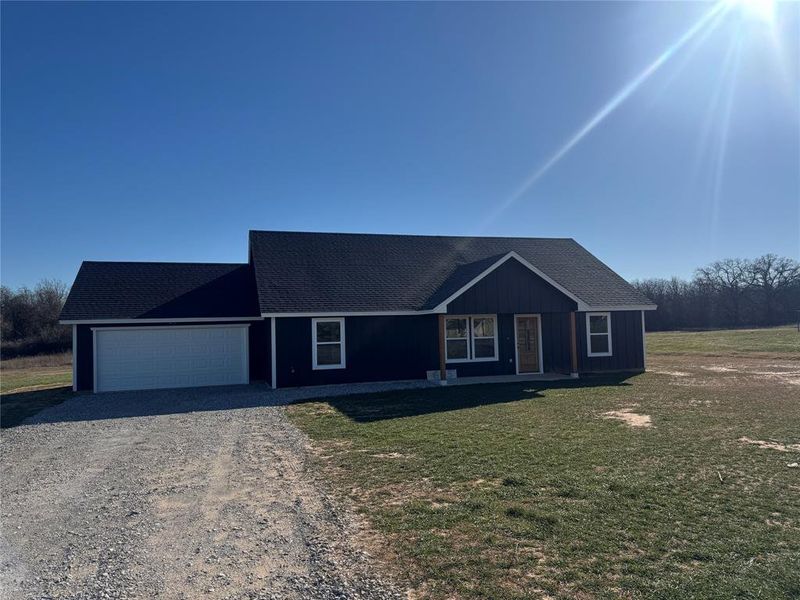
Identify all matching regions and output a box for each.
[1,374,632,428]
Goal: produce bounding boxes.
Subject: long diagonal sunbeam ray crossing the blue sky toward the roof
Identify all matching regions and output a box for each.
[483,2,730,229]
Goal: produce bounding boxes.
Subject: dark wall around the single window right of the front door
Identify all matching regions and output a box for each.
[576,310,644,373]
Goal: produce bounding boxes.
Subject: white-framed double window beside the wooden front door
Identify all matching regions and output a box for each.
[444,315,498,363]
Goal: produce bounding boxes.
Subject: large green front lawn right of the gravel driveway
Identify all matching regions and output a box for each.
[287,332,800,599]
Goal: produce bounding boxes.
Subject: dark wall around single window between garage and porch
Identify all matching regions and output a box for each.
[275,315,439,387]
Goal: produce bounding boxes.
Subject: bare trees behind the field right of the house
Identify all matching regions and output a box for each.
[631,254,800,331]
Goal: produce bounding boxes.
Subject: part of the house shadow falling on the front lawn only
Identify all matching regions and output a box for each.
[316,373,636,423]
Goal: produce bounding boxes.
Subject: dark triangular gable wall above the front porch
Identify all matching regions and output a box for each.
[447,259,577,315]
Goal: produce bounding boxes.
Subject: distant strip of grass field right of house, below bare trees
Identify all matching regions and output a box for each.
[647,327,800,356]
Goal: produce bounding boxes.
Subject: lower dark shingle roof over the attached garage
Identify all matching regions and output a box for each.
[60,261,259,323]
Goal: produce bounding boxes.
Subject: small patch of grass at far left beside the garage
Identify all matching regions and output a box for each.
[0,353,72,428]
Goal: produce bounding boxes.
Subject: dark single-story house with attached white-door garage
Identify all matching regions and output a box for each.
[61,231,656,392]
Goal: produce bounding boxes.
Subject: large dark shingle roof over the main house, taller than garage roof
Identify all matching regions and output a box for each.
[250,231,655,315]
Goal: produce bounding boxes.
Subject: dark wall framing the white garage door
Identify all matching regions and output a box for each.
[71,319,271,391]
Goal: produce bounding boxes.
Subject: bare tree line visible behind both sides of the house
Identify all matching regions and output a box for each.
[0,254,800,358]
